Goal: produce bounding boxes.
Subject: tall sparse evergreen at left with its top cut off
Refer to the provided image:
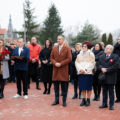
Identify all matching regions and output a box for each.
[18,0,39,41]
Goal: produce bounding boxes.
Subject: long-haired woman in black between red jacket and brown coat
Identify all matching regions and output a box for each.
[40,40,53,94]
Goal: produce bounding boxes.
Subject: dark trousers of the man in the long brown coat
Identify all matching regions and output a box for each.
[54,81,68,102]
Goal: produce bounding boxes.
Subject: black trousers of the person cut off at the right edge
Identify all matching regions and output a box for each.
[115,70,120,100]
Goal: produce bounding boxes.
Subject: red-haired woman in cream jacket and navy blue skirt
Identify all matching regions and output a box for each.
[75,41,95,106]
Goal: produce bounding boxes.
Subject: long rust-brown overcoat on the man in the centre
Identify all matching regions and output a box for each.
[50,46,72,82]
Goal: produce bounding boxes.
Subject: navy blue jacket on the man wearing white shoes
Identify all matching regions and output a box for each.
[12,46,30,71]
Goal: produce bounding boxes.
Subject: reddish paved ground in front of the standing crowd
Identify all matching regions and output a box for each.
[0,83,120,120]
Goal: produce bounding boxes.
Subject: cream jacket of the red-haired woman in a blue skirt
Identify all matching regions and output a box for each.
[75,50,95,74]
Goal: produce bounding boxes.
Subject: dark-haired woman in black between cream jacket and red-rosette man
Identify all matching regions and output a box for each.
[93,43,104,101]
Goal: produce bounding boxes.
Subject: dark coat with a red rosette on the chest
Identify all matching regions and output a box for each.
[99,54,119,85]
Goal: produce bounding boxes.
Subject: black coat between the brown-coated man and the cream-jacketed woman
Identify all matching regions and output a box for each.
[71,51,80,80]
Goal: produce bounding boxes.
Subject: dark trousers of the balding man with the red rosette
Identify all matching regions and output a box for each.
[103,85,114,106]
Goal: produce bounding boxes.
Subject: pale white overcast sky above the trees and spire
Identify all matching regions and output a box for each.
[0,0,120,32]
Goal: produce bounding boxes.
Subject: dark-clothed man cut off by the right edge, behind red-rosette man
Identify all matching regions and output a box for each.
[114,37,120,103]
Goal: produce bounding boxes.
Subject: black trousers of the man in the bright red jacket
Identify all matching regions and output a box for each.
[27,62,39,86]
